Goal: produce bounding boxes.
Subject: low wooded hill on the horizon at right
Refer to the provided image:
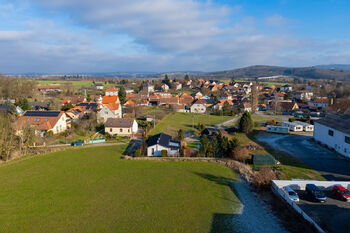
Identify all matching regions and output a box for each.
[200,65,350,80]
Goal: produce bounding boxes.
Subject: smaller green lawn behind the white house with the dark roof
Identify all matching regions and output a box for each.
[150,113,233,136]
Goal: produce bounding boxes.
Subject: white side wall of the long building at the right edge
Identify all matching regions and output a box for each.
[314,121,350,158]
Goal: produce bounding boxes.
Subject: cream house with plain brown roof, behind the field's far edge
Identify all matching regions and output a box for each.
[105,118,138,137]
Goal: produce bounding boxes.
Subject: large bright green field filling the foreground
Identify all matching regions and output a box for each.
[0,146,240,233]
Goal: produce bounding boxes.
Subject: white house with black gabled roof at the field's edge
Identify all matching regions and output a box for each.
[147,133,181,157]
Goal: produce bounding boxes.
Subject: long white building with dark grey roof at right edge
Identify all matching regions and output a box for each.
[314,114,350,157]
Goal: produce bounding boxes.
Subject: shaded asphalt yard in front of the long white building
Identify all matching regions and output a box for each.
[258,134,350,181]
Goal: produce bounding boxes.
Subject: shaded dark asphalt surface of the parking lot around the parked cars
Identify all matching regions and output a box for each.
[296,190,350,233]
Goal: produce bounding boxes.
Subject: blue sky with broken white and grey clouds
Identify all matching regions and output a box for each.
[0,0,350,74]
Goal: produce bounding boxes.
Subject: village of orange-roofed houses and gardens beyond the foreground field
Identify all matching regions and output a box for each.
[0,75,350,233]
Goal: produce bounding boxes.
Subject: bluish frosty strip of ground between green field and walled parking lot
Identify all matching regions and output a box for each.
[233,182,287,233]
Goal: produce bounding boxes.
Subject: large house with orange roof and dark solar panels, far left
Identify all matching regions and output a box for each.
[14,111,67,136]
